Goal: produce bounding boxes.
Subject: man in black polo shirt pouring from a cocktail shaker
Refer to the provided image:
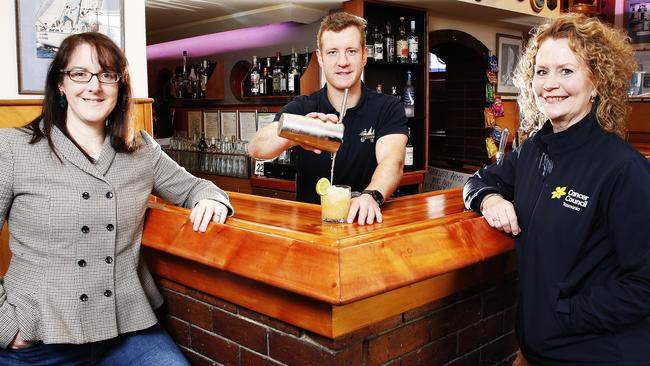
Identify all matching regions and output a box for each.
[249,12,408,225]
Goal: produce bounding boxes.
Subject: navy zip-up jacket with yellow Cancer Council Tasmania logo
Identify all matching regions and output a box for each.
[463,114,650,365]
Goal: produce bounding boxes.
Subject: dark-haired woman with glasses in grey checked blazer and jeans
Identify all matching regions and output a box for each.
[0,33,233,365]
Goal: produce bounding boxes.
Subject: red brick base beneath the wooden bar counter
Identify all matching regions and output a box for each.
[158,274,517,366]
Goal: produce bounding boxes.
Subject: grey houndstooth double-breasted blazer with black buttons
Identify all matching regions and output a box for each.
[0,127,233,348]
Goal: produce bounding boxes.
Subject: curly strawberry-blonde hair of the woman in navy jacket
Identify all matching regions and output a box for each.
[513,13,636,137]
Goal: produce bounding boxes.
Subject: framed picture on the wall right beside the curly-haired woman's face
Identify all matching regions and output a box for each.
[496,33,524,95]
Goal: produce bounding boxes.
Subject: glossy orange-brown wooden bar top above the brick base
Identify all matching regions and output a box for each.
[143,189,514,305]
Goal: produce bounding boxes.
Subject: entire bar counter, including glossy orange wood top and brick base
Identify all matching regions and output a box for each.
[143,189,516,365]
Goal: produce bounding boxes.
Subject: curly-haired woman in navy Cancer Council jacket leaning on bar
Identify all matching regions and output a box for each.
[464,14,650,365]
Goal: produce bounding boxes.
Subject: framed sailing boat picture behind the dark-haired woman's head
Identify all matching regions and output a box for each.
[15,0,124,94]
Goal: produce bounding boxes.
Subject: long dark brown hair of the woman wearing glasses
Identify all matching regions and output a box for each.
[26,32,138,160]
